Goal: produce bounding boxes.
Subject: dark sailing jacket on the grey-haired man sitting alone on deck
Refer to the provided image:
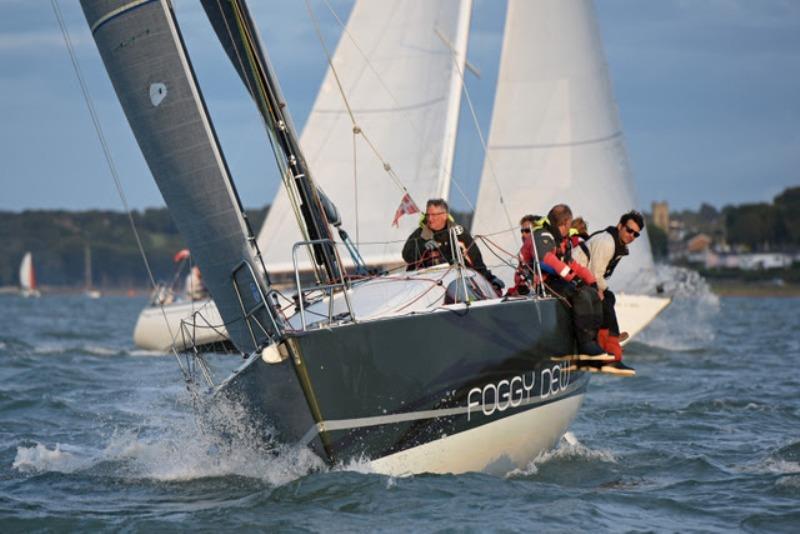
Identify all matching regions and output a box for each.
[403,218,495,282]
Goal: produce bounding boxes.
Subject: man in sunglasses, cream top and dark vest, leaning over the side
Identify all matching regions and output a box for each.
[575,211,644,375]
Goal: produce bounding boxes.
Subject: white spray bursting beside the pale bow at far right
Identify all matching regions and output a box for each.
[636,265,720,351]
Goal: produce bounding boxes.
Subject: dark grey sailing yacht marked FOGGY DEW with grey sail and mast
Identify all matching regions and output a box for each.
[81,0,656,475]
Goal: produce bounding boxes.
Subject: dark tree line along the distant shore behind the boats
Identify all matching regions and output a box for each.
[0,187,800,288]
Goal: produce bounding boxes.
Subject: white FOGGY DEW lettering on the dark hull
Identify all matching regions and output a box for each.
[467,362,570,421]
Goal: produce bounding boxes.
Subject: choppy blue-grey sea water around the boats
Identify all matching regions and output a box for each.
[0,285,800,533]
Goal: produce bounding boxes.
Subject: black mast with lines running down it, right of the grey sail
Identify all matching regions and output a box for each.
[202,0,340,283]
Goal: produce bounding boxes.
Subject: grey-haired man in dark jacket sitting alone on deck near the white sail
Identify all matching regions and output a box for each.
[403,198,505,292]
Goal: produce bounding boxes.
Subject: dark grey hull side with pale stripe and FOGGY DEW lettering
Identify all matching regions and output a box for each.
[217,299,589,474]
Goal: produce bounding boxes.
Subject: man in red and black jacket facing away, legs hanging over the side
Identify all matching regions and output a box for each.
[516,204,605,356]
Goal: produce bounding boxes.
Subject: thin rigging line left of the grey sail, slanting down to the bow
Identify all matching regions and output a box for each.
[50,0,190,381]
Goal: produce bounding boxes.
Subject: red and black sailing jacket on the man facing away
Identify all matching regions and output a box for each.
[514,219,597,287]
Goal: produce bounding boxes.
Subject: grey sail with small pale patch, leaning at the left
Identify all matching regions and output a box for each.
[81,0,277,352]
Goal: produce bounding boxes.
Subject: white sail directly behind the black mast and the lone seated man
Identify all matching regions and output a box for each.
[258,0,471,272]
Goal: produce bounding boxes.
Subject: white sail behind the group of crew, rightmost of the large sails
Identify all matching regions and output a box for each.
[472,0,653,290]
